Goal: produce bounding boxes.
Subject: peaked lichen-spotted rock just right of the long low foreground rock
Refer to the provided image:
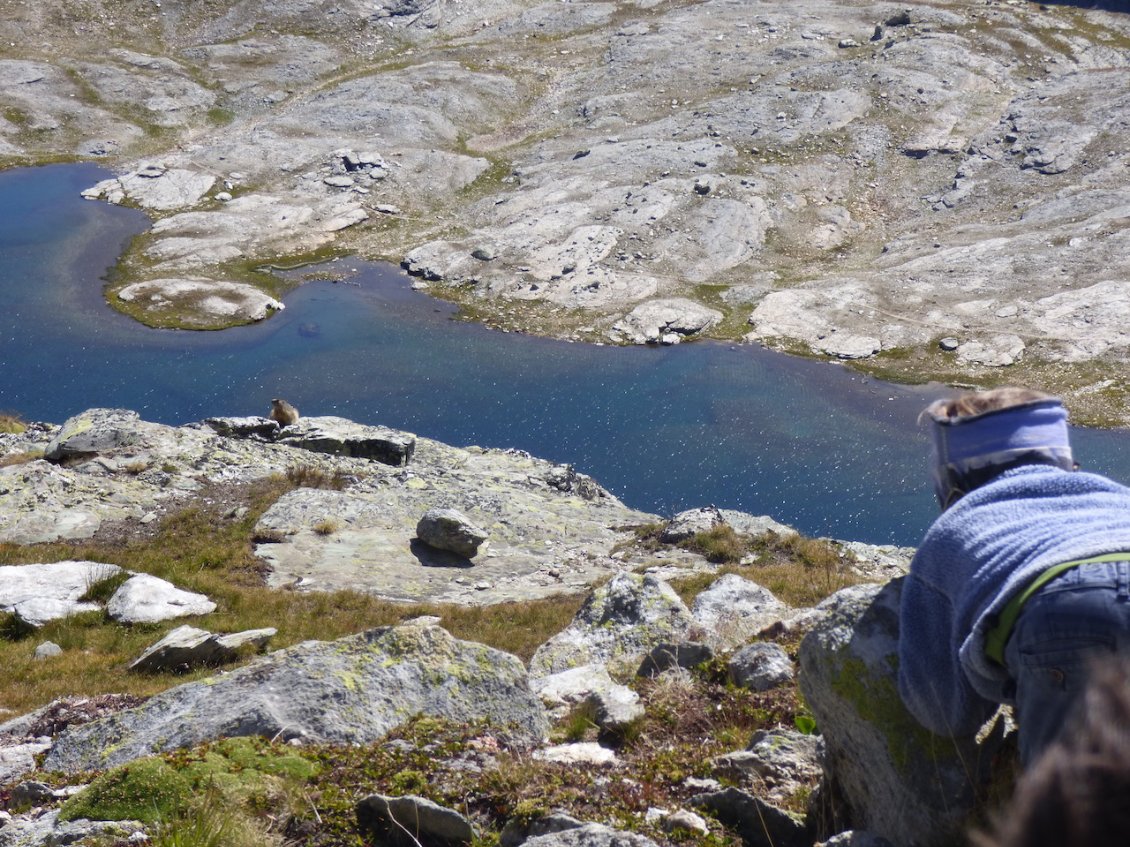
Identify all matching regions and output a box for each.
[530,571,694,678]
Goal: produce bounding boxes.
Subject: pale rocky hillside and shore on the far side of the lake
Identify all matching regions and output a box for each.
[0,0,1130,424]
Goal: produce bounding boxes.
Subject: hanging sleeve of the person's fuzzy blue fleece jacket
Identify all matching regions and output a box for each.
[898,566,997,737]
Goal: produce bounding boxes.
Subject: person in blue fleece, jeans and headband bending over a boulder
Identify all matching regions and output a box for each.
[899,388,1130,761]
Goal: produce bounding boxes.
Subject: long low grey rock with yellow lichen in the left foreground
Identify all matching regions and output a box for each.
[44,623,547,772]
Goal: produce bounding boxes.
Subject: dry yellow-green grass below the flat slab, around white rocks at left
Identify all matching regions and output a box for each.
[0,475,582,713]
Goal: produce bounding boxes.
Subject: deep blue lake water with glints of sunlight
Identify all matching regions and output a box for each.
[0,165,1130,544]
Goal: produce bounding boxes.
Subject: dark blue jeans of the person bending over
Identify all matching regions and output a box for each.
[1005,561,1130,766]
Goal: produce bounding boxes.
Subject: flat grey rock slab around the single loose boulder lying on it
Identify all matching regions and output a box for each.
[247,438,654,604]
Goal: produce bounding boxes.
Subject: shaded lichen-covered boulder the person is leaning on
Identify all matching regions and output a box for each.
[800,579,1000,847]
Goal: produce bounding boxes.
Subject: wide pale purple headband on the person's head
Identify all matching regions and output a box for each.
[930,399,1075,508]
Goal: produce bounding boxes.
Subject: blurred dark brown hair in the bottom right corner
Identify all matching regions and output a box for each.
[973,660,1130,847]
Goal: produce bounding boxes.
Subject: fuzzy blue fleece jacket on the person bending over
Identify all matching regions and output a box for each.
[898,465,1130,736]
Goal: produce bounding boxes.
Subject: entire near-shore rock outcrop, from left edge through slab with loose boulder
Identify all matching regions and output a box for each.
[0,409,657,604]
